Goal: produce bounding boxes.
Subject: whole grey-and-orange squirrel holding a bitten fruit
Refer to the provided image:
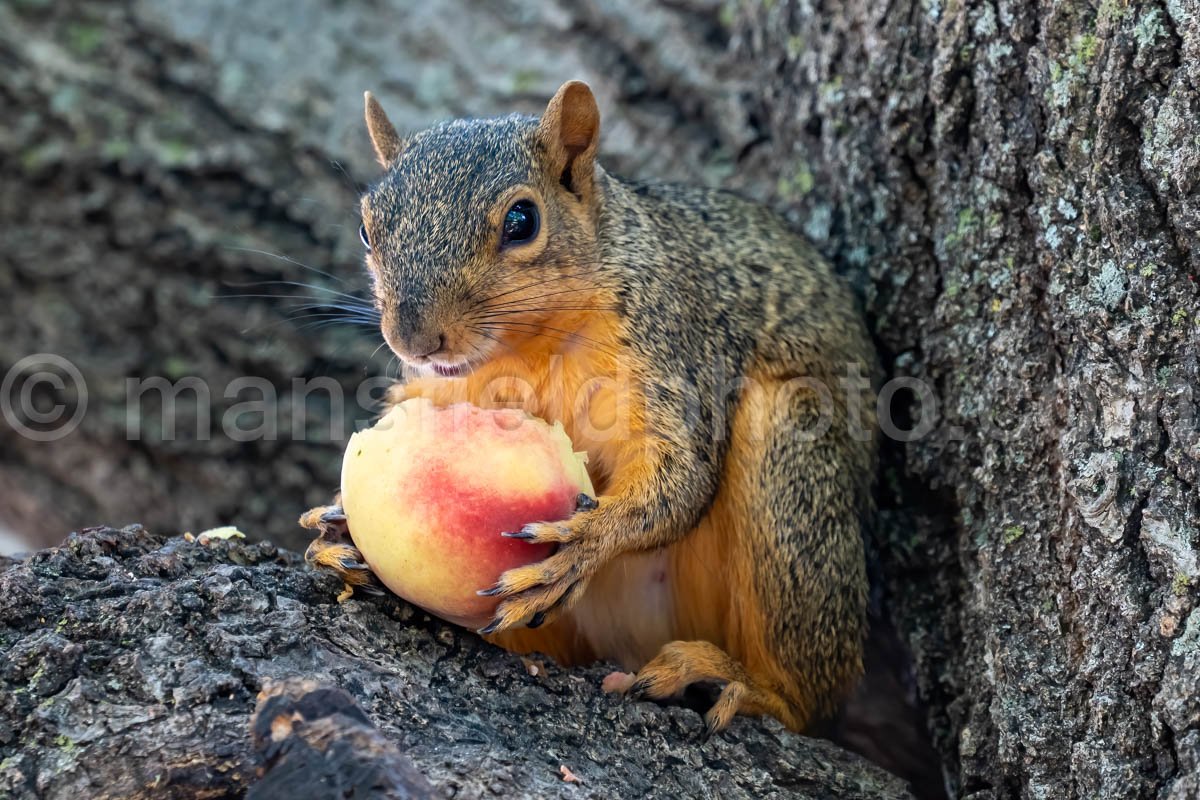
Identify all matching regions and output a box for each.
[301,80,876,734]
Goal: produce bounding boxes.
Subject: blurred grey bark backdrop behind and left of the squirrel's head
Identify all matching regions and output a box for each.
[0,0,774,551]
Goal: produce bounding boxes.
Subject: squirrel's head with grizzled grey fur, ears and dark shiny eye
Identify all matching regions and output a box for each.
[352,80,600,375]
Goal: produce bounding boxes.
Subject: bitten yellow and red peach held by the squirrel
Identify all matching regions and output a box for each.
[342,398,593,627]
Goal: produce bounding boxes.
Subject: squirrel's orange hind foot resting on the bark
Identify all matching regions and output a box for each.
[625,642,803,739]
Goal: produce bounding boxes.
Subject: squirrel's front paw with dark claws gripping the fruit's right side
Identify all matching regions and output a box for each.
[479,494,611,634]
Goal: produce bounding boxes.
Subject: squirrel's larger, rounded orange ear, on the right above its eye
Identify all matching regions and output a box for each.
[538,80,600,197]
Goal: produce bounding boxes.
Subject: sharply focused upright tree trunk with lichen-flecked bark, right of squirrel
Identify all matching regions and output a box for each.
[736,0,1200,798]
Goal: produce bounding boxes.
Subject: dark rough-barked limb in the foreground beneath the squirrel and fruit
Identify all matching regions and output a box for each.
[0,528,908,800]
